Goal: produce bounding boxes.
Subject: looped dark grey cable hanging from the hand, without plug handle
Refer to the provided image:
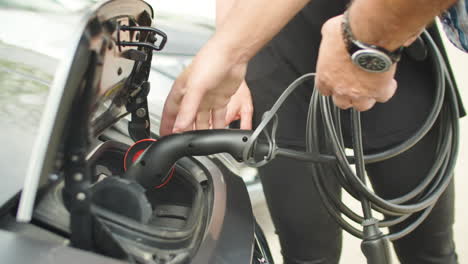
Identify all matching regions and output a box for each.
[243,32,459,243]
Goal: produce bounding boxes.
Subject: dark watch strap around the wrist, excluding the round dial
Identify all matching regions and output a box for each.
[341,10,404,63]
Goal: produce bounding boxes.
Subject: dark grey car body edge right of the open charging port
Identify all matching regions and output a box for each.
[193,157,254,264]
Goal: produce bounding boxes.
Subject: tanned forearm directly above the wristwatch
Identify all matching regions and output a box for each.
[349,0,456,50]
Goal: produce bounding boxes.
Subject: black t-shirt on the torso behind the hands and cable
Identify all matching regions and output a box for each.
[246,0,462,152]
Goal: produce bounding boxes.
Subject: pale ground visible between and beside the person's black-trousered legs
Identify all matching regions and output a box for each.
[254,29,468,264]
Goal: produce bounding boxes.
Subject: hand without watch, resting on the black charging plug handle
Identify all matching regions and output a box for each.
[160,39,247,136]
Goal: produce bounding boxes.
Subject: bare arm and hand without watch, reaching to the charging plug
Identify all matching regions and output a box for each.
[160,0,310,135]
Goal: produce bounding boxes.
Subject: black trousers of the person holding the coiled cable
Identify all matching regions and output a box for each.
[260,124,457,264]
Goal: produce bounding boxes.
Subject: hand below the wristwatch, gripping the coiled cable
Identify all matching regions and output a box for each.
[315,16,397,111]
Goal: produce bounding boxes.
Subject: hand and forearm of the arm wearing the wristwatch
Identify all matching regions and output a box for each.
[316,0,457,111]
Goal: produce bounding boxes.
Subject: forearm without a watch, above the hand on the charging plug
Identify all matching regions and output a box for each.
[211,0,310,63]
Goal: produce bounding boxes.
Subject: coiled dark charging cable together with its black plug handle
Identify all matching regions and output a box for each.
[124,28,459,264]
